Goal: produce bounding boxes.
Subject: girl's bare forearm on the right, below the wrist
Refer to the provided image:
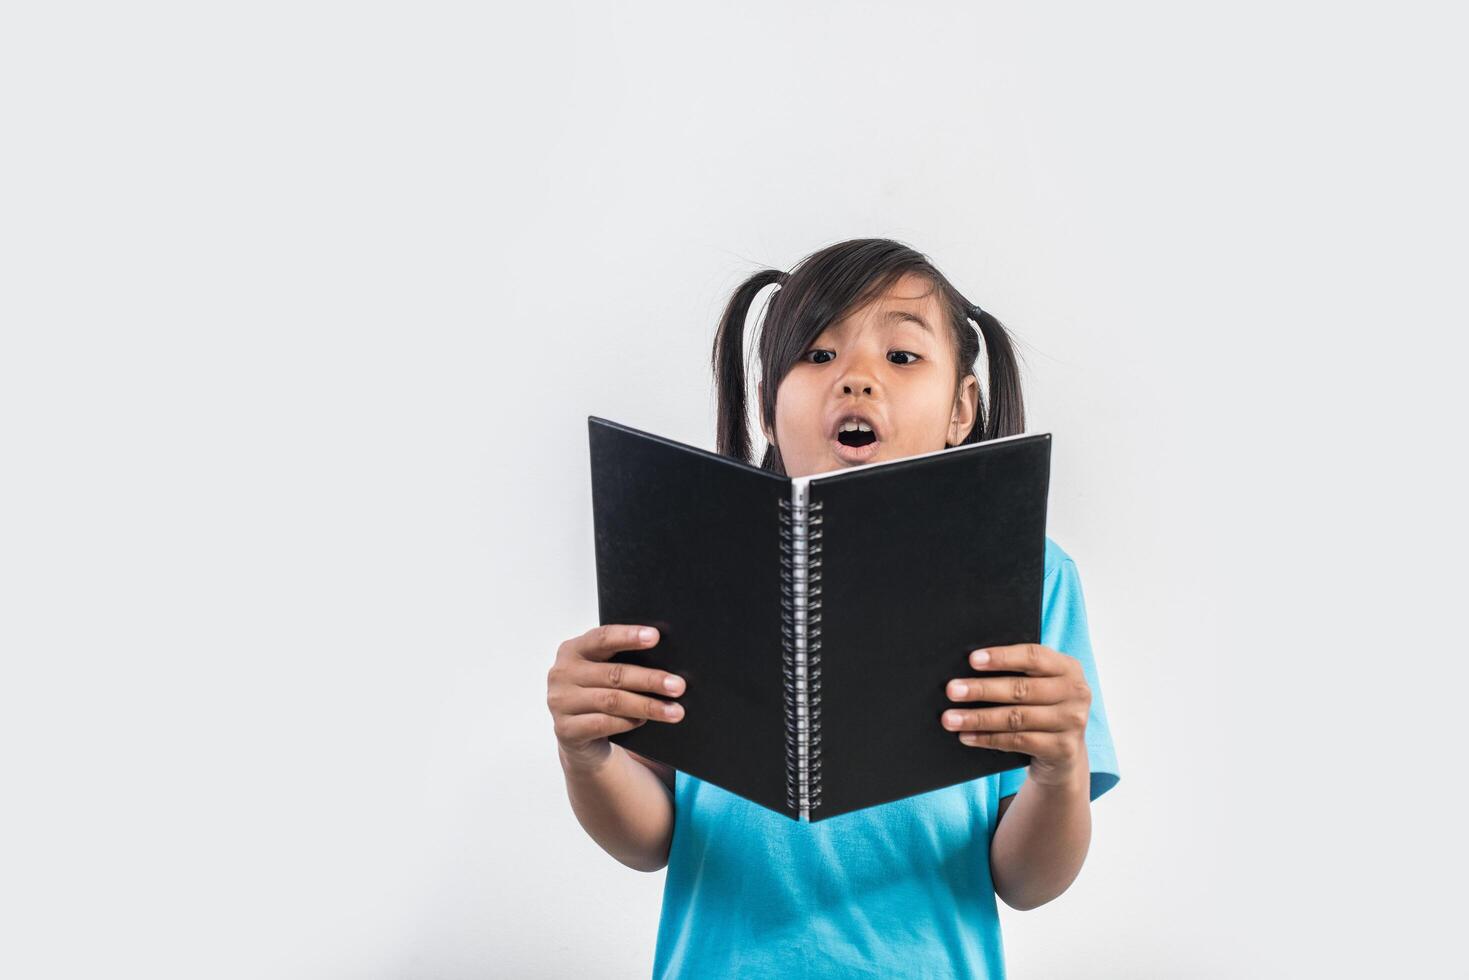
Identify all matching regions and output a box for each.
[990,765,1091,911]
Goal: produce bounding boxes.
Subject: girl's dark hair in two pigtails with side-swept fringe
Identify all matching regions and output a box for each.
[712,238,1025,475]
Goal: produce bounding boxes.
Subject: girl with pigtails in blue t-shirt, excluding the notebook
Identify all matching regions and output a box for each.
[546,238,1118,979]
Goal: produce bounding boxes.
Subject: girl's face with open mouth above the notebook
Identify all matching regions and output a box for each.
[761,273,978,476]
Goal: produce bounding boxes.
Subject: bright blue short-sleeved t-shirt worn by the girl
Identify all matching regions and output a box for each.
[654,538,1119,980]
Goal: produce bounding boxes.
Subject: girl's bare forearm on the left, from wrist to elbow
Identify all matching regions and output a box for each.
[557,745,673,871]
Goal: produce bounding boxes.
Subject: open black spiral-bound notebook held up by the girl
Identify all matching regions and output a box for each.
[588,416,1050,821]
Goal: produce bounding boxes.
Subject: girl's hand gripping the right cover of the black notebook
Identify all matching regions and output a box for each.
[940,644,1091,786]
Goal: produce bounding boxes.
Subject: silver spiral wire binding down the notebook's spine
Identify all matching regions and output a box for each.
[780,482,821,820]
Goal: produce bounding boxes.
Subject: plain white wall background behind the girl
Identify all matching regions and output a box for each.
[0,1,1469,979]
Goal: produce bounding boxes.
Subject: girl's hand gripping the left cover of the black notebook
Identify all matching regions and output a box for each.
[546,624,685,768]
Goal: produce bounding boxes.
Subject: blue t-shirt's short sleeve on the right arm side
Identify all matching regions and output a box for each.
[999,538,1121,799]
